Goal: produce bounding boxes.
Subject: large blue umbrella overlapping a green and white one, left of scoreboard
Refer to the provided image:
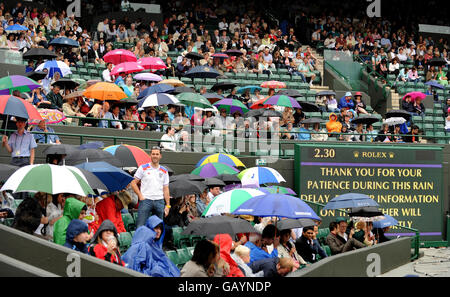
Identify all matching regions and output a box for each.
[232,194,321,221]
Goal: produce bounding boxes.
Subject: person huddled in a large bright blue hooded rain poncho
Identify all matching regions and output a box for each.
[123,215,180,277]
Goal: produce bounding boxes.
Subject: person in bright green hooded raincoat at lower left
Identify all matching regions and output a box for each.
[53,198,87,245]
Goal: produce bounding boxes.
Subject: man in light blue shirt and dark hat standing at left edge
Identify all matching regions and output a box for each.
[2,117,37,167]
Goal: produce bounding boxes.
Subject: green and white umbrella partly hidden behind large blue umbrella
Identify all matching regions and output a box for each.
[202,189,266,217]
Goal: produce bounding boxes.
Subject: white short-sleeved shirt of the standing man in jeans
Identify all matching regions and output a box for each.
[134,163,169,200]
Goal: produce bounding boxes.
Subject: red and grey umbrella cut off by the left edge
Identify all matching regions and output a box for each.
[0,95,42,121]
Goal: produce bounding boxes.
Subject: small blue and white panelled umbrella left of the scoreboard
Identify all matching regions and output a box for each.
[238,167,286,187]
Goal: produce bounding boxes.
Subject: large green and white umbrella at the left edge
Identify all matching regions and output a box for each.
[0,164,94,196]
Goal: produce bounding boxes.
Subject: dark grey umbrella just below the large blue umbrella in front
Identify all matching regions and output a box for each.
[181,216,259,236]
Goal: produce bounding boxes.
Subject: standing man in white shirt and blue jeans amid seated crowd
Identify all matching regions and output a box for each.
[131,146,170,228]
